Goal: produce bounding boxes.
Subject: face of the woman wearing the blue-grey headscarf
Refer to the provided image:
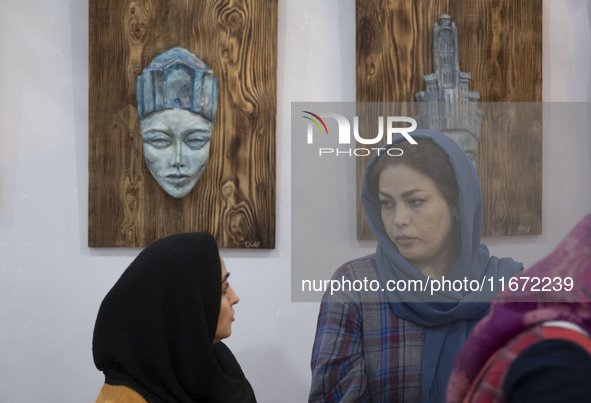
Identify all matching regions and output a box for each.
[379,165,457,277]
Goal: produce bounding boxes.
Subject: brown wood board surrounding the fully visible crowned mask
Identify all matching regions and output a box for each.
[88,0,277,248]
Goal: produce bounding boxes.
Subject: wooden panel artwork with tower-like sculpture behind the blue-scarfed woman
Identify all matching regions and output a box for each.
[356,0,542,240]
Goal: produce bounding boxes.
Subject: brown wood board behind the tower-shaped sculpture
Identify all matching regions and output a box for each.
[356,0,542,239]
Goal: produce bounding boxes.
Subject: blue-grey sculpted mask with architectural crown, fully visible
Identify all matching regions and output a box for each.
[136,48,219,199]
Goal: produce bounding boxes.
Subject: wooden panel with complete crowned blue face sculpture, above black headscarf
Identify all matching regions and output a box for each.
[88,0,277,249]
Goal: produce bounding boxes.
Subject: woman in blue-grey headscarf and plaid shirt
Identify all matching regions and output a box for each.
[309,130,522,402]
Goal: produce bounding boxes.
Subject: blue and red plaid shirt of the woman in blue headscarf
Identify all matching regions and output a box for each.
[309,255,425,402]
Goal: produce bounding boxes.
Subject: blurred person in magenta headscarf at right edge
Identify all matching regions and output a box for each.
[447,214,591,403]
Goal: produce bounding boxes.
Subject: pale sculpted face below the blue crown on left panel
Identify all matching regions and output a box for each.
[140,108,213,199]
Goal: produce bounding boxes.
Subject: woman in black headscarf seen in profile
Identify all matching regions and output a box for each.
[93,232,256,403]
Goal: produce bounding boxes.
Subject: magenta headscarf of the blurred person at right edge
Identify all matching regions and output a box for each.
[447,214,591,403]
